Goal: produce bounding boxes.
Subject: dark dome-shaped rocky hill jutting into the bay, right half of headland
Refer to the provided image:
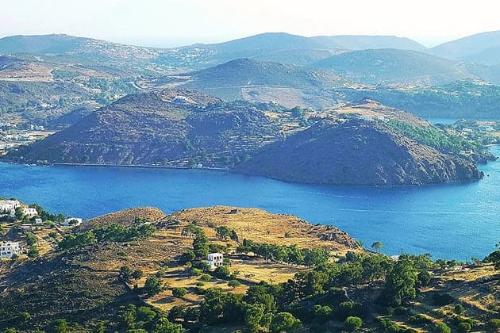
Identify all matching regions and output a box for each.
[237,119,480,185]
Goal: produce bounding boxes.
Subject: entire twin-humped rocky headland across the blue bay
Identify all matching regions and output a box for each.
[5,90,481,185]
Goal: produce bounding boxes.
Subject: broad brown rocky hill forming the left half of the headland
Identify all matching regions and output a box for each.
[2,90,290,168]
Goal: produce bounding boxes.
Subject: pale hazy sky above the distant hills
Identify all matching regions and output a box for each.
[0,0,500,46]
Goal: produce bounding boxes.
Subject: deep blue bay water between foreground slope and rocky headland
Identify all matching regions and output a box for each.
[0,147,500,259]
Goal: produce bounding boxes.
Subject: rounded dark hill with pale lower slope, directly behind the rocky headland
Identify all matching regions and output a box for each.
[162,59,345,107]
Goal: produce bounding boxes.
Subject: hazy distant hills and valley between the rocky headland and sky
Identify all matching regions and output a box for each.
[0,32,500,123]
